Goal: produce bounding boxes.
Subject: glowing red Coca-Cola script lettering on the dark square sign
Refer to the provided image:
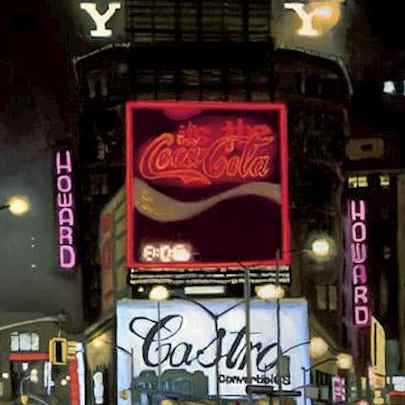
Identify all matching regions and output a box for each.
[138,119,274,186]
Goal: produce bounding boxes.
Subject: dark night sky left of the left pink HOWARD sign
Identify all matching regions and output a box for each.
[0,0,81,327]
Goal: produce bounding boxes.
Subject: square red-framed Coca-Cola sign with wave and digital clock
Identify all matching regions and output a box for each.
[126,102,290,268]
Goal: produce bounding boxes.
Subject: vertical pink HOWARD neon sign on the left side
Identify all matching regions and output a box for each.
[55,150,76,270]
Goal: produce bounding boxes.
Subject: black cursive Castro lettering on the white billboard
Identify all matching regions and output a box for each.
[129,315,277,372]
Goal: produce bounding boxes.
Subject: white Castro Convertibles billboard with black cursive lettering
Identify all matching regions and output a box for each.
[117,299,310,405]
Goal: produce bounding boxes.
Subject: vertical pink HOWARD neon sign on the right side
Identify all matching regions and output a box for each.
[349,200,370,327]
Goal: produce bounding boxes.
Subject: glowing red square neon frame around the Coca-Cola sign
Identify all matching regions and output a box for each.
[125,101,291,270]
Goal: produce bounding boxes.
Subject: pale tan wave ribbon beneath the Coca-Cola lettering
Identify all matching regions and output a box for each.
[134,178,281,222]
